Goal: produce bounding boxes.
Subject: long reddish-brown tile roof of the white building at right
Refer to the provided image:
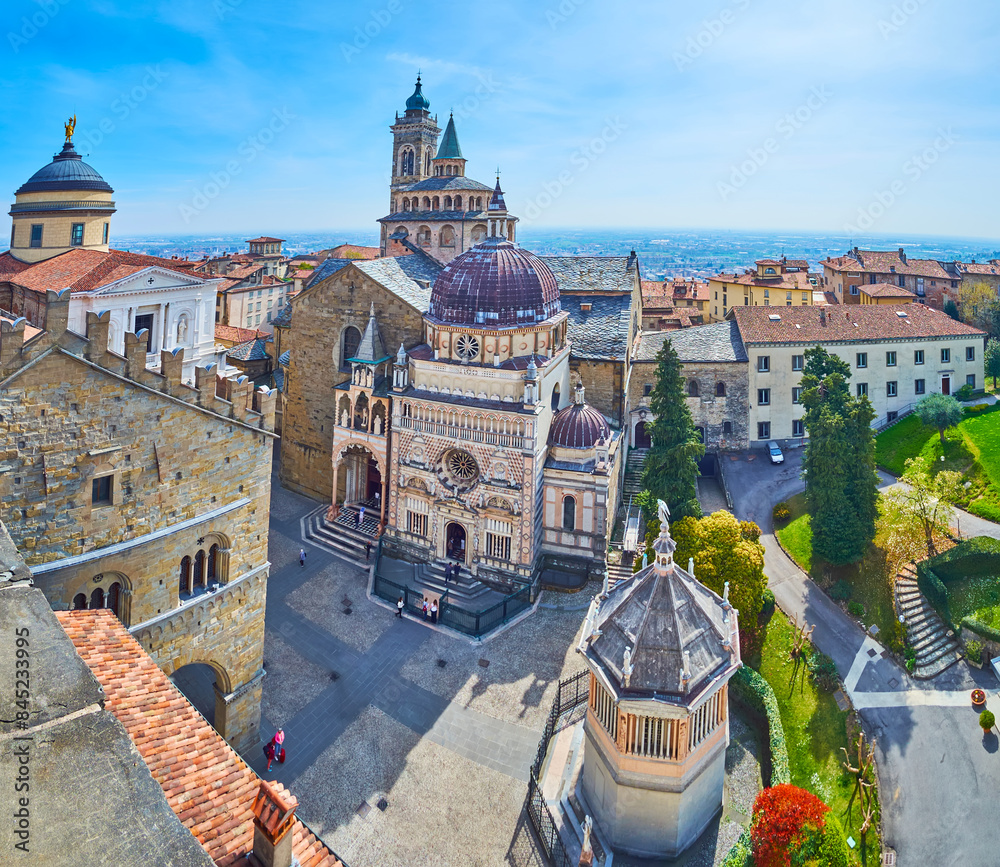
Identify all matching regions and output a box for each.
[729,304,985,344]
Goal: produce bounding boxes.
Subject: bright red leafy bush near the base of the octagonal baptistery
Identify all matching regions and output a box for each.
[750,783,830,867]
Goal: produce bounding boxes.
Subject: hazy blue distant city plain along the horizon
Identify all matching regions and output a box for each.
[115,227,1000,279]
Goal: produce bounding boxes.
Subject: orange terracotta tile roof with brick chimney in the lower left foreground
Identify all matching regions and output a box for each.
[56,610,343,867]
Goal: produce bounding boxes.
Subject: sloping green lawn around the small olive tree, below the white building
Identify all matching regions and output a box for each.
[875,404,1000,522]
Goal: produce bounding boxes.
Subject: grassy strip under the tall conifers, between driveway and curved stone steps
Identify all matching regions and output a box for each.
[775,494,896,636]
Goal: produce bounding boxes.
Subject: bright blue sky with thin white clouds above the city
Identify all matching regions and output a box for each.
[0,0,1000,238]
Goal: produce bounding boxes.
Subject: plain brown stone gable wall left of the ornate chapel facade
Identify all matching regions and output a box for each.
[280,265,424,501]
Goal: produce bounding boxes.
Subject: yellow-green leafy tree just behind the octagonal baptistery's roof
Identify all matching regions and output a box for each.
[670,511,767,656]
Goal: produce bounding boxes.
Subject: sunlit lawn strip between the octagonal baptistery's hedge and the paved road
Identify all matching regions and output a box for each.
[760,610,881,867]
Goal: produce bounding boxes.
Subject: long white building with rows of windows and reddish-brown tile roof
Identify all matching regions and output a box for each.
[730,304,986,445]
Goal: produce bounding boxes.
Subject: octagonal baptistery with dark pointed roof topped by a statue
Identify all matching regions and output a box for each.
[579,503,741,858]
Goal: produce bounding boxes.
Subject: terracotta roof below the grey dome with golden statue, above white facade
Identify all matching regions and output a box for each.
[0,250,219,293]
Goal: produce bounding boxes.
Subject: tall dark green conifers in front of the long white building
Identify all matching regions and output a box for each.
[801,346,878,565]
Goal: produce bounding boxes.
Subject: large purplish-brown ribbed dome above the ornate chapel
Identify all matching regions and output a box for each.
[428,237,560,328]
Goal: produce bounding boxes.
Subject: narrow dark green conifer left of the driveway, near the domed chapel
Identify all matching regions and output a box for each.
[642,340,705,518]
